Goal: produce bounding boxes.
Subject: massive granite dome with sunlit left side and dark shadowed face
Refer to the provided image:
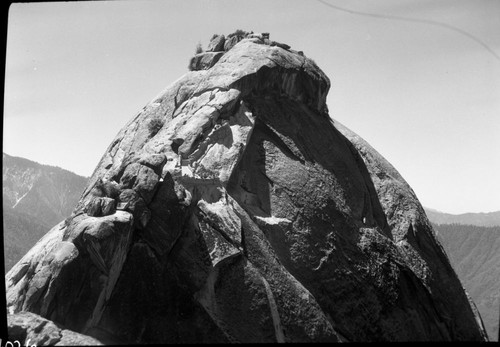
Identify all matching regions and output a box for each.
[6,33,484,343]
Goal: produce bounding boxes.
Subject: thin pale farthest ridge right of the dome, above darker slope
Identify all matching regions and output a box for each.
[424,207,500,227]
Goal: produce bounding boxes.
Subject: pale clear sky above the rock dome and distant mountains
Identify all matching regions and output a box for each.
[3,0,500,214]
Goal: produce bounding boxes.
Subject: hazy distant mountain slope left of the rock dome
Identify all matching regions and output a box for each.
[2,153,88,271]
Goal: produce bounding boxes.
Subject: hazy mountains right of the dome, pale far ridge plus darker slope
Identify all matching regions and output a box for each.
[424,207,500,341]
